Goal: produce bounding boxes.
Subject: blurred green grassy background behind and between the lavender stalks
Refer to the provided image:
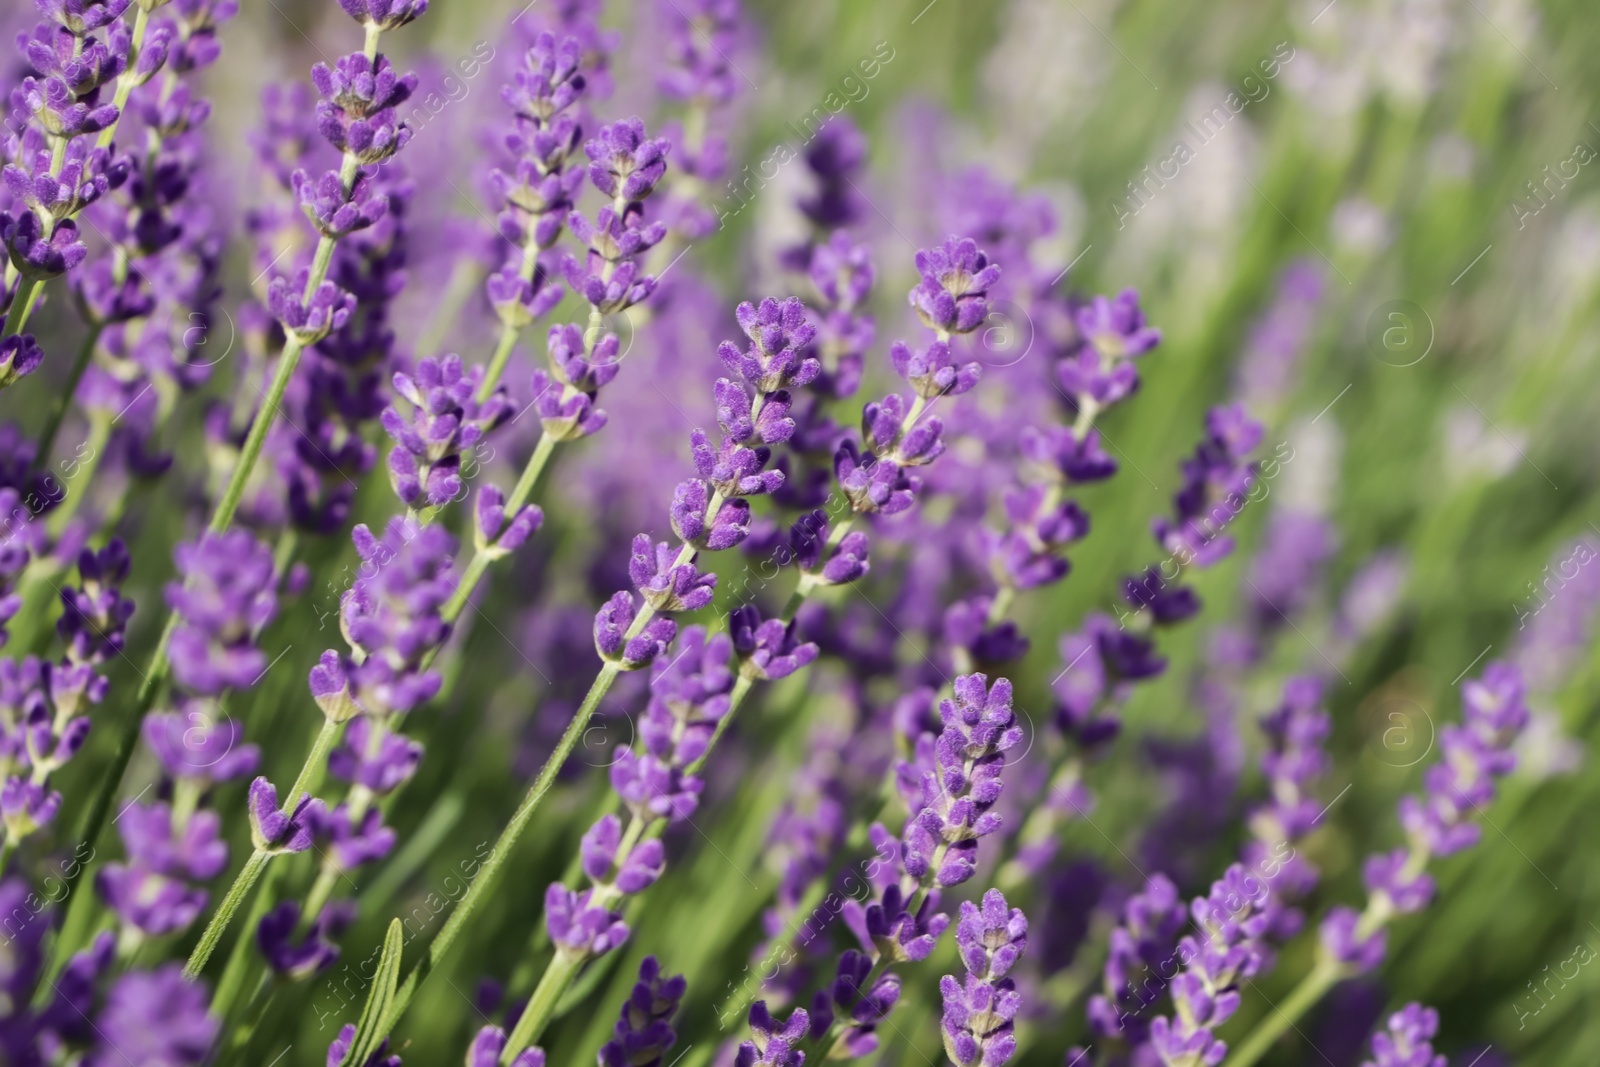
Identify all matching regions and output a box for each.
[18,0,1600,1067]
